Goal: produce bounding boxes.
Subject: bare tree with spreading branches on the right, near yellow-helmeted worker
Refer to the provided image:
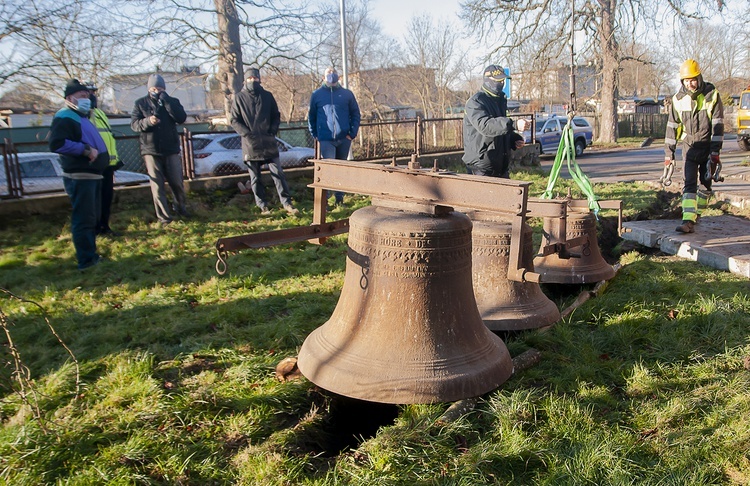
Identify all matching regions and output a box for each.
[462,0,741,142]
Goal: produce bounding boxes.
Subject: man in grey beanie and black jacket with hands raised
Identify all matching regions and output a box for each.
[130,74,190,225]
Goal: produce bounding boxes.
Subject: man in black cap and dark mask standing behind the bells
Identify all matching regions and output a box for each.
[463,64,526,179]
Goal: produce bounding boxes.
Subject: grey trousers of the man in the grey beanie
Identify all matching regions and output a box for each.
[143,154,186,223]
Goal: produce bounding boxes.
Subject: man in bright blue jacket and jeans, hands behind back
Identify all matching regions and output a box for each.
[307,67,361,205]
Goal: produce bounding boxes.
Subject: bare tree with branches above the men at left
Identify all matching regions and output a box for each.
[133,0,314,117]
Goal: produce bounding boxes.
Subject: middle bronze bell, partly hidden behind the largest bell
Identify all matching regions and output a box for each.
[472,212,560,331]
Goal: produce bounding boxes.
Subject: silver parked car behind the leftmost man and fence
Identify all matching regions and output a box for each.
[0,152,149,194]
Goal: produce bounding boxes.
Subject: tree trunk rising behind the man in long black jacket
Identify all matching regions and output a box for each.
[214,0,244,118]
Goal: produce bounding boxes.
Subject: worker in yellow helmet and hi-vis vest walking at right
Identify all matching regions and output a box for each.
[664,59,724,233]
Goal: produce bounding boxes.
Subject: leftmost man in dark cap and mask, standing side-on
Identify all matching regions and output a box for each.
[49,79,109,270]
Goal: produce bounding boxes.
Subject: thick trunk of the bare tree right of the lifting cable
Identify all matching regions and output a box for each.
[597,0,620,143]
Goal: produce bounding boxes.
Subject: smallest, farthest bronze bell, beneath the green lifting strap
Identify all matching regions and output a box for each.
[534,210,615,284]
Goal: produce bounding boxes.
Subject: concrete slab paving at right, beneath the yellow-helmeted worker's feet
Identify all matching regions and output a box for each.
[622,215,750,278]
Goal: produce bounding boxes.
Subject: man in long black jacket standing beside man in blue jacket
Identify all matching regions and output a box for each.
[229,68,299,214]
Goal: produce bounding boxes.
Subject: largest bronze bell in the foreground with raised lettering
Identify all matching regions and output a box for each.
[298,206,513,404]
